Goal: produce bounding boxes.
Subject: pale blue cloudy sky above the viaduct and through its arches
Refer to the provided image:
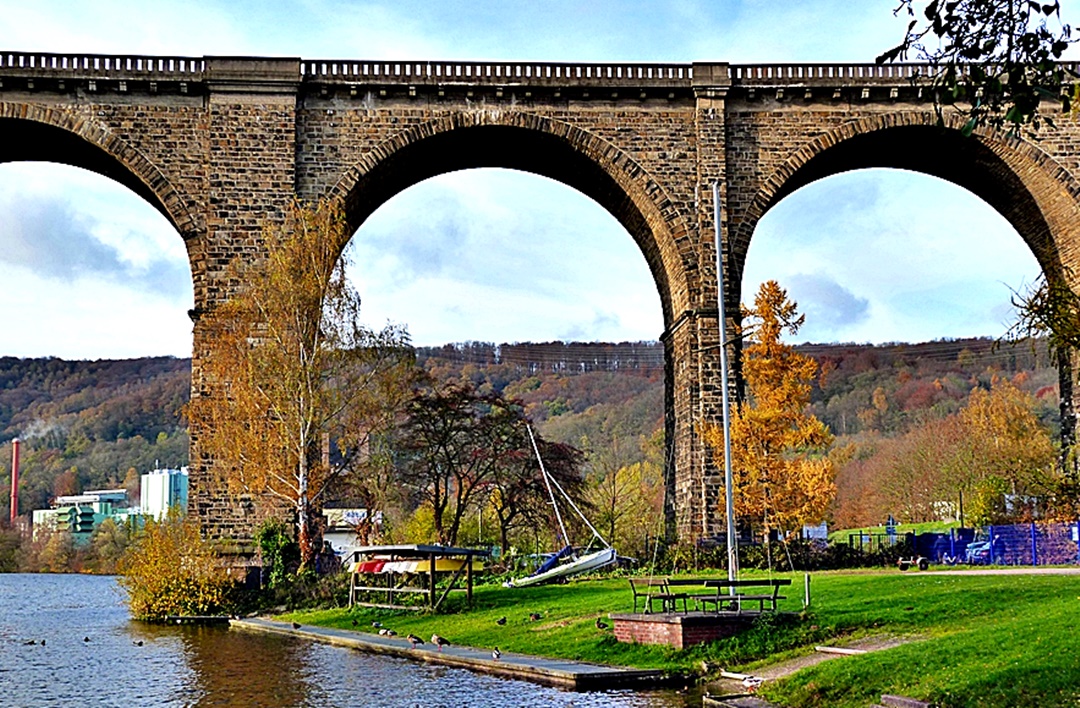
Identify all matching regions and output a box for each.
[0,0,1068,359]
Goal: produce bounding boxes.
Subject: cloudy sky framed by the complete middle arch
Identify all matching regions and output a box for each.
[350,168,663,346]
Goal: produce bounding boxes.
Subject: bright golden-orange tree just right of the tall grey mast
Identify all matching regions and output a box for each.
[703,281,836,534]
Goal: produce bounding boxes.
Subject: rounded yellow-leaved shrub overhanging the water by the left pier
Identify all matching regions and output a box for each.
[118,512,238,621]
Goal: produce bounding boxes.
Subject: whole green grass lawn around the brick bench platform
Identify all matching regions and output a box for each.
[286,570,1080,707]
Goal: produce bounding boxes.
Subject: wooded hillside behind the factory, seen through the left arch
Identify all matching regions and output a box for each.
[0,357,191,518]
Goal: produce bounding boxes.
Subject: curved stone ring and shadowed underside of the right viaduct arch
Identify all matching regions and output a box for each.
[729,111,1080,287]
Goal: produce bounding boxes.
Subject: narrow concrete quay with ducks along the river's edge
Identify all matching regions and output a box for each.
[229,617,669,690]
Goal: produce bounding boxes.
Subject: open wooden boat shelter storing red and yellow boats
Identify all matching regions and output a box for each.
[349,544,490,611]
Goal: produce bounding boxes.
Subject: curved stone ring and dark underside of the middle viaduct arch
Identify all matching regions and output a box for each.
[330,110,696,327]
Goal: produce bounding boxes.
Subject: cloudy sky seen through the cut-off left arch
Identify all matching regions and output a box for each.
[0,162,193,359]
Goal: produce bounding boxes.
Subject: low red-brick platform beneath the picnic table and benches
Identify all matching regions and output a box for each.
[611,612,757,649]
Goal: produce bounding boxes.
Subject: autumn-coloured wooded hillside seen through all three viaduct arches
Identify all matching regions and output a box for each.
[0,339,1058,526]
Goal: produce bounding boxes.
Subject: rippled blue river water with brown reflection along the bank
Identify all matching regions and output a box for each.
[0,574,701,708]
